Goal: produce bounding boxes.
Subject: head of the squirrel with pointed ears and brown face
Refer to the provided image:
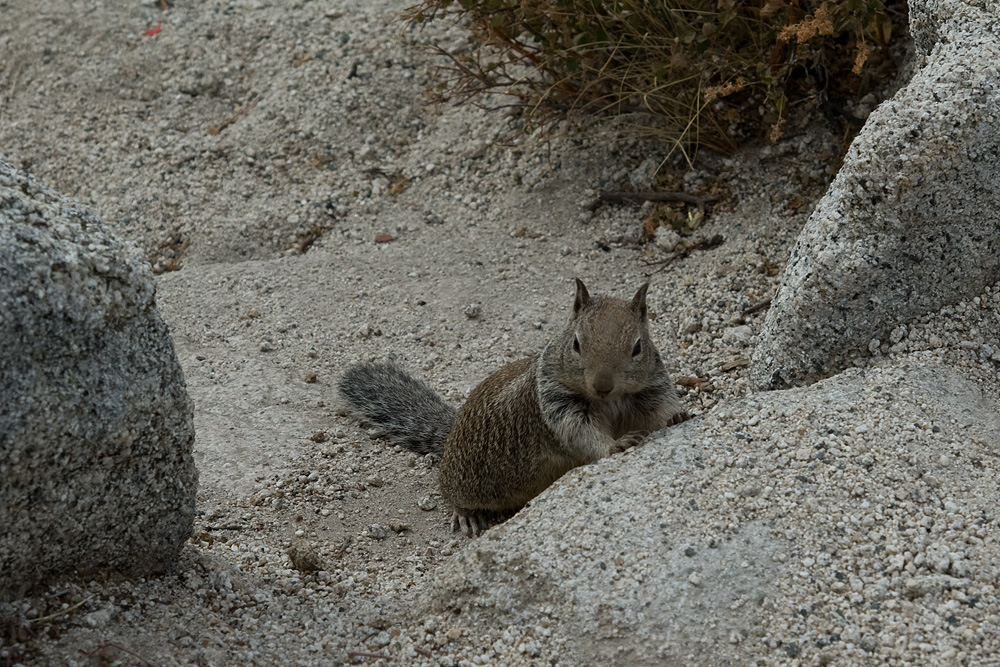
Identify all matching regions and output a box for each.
[560,278,660,402]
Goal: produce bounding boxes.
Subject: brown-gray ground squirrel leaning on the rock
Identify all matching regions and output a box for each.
[338,279,688,537]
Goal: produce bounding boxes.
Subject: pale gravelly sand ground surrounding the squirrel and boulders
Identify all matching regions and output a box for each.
[0,0,940,665]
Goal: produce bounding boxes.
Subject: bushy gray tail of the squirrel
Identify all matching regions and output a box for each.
[337,364,457,454]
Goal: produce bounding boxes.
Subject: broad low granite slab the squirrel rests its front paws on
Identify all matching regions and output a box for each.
[421,360,1000,665]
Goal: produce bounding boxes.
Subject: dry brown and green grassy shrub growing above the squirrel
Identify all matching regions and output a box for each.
[409,0,906,158]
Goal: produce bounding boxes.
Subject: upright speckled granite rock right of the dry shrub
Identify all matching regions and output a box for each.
[751,2,1000,388]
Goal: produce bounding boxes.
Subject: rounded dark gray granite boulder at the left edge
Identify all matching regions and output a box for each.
[0,162,197,599]
